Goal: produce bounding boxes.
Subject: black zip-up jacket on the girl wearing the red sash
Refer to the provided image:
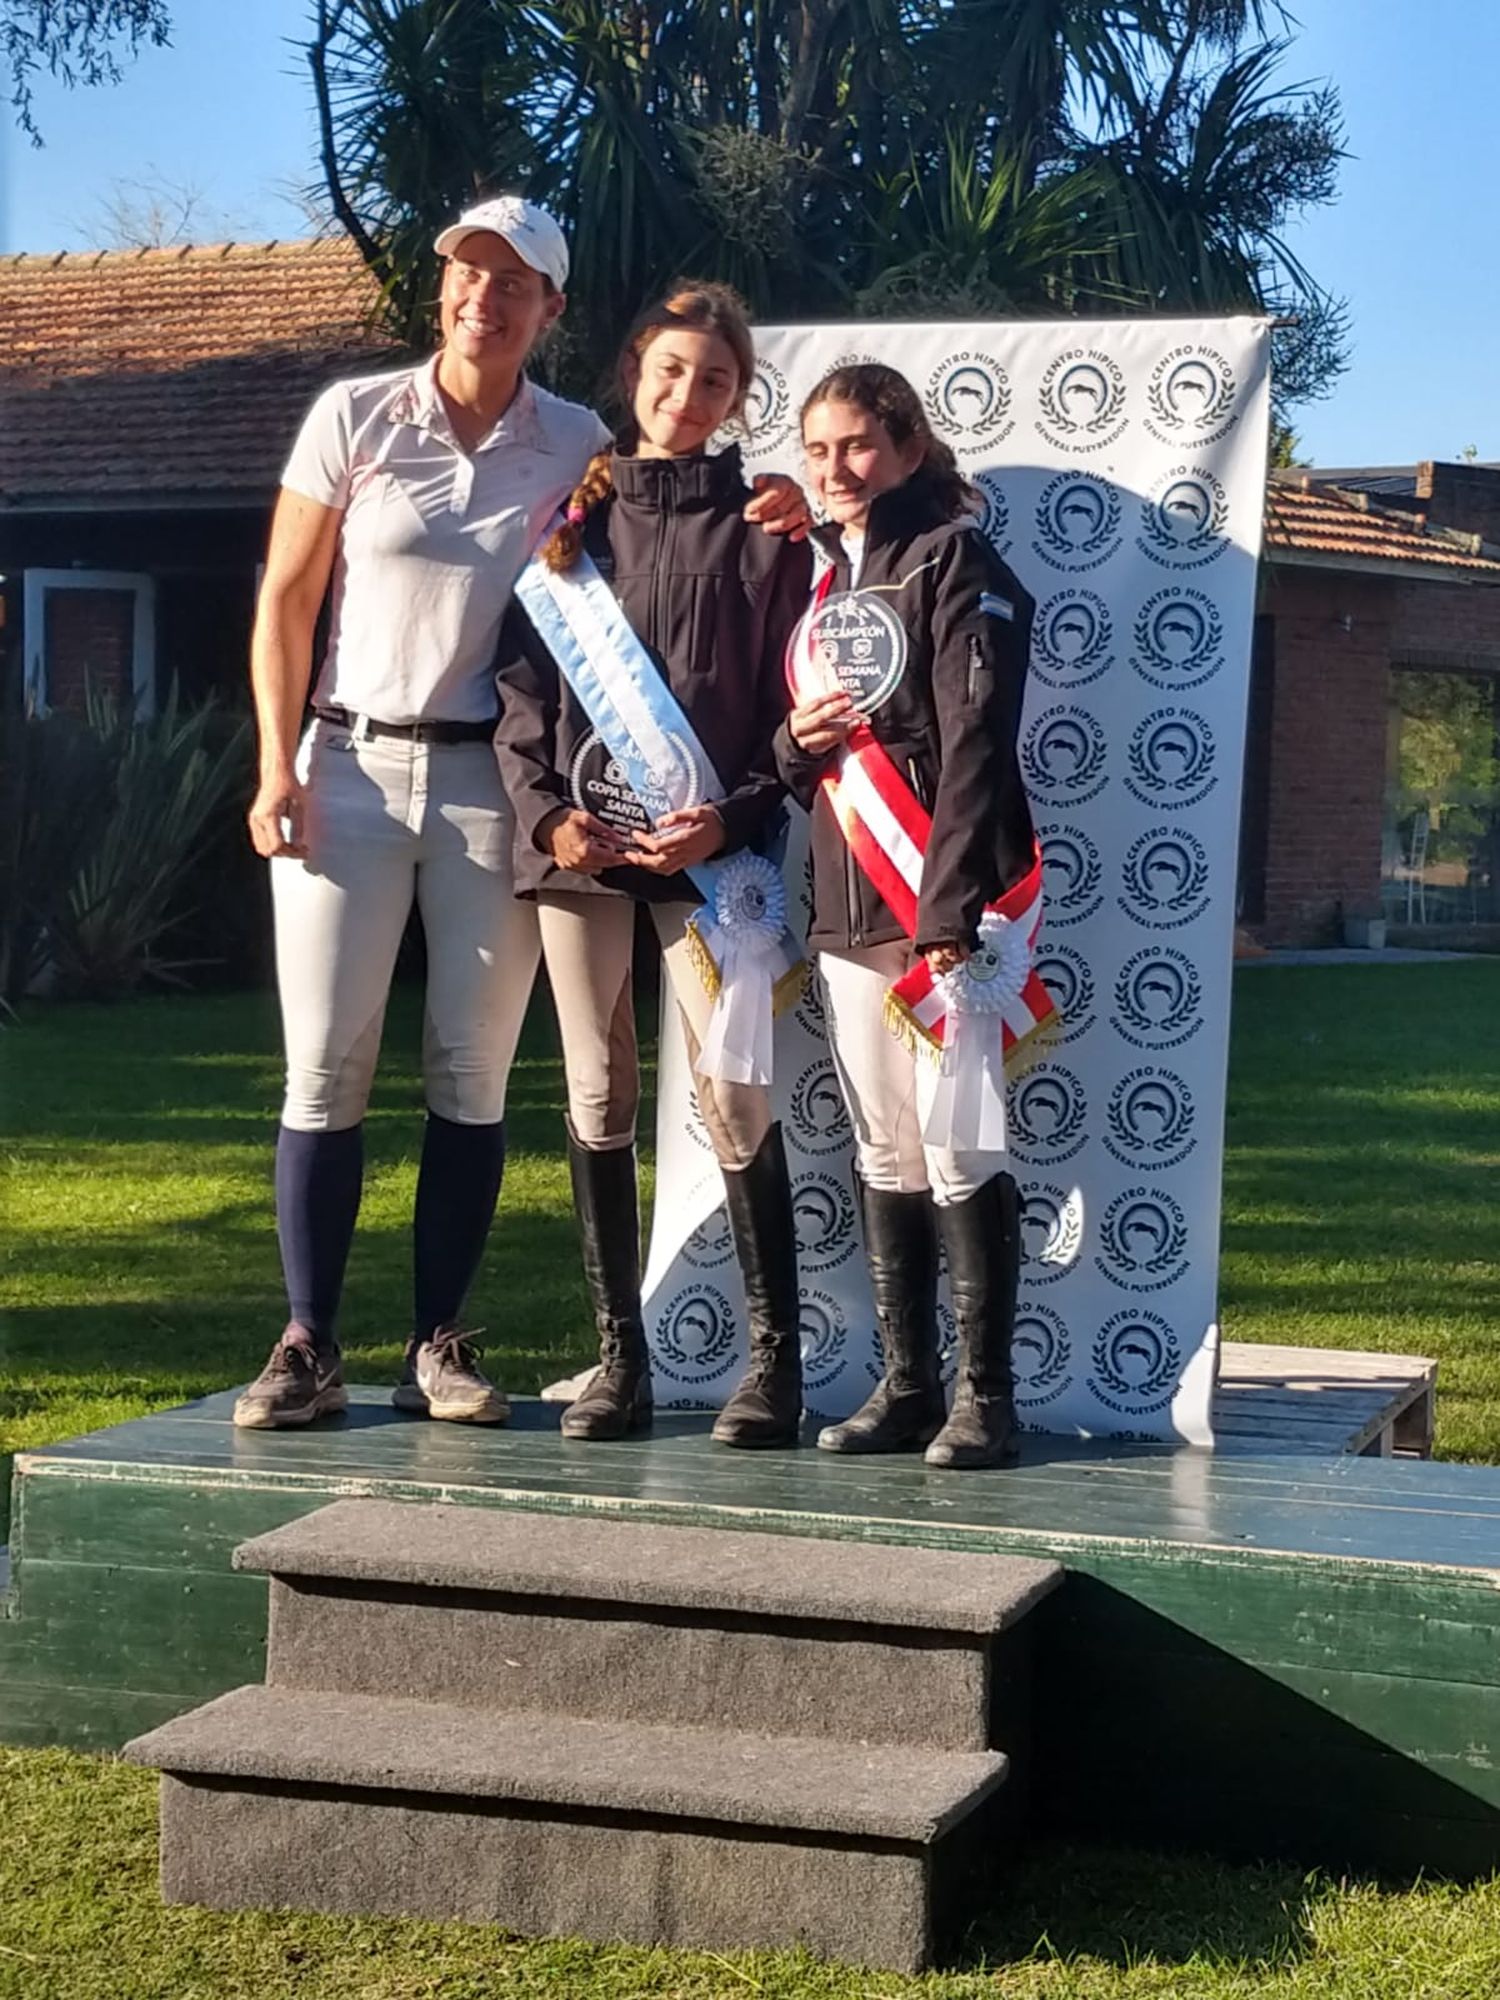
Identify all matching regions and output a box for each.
[776,472,1036,950]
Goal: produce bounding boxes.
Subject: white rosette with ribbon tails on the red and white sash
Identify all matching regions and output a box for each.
[922,912,1032,1152]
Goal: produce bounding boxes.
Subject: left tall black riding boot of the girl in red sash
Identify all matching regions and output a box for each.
[818,1174,946,1452]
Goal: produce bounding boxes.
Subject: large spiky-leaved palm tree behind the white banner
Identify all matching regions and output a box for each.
[308,0,1342,406]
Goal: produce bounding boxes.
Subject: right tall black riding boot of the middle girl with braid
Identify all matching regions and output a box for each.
[714,1126,802,1448]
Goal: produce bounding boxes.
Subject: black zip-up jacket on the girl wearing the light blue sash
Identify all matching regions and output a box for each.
[496,448,812,902]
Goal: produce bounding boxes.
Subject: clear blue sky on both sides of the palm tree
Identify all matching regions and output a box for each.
[0,0,1500,464]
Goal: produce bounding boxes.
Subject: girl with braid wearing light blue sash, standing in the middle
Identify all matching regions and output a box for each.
[496,282,812,1446]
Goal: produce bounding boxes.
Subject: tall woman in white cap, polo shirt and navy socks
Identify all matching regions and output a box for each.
[234,196,804,1428]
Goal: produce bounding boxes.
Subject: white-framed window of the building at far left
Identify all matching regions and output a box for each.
[22,570,156,716]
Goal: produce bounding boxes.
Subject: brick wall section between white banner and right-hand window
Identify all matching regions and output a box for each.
[1258,566,1406,944]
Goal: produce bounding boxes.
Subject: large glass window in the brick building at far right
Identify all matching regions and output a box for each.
[1382,670,1500,928]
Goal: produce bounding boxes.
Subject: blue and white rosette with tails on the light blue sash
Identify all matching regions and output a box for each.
[692,850,792,1084]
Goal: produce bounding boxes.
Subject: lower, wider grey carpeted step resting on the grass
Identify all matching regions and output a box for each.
[124,1688,1006,1972]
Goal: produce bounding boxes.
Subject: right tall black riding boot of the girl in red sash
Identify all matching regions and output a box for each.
[926,1174,1020,1472]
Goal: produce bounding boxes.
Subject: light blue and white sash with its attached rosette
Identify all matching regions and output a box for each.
[516,554,804,1084]
